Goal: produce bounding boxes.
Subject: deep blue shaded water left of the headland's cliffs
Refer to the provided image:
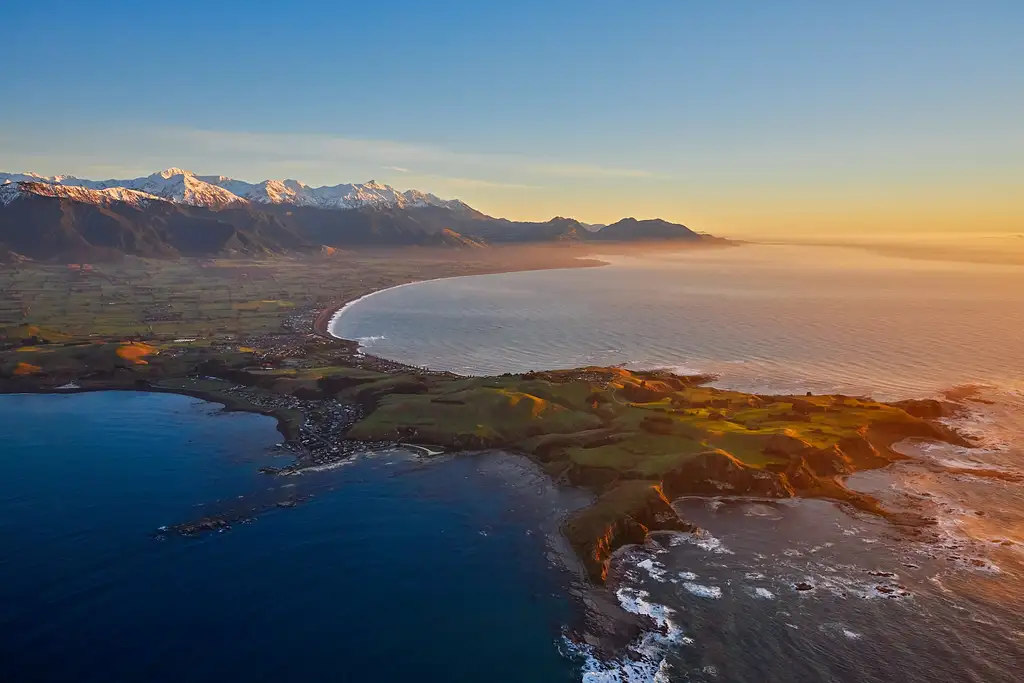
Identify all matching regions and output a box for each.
[0,392,579,683]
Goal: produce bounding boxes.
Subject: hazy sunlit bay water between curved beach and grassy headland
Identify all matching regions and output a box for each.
[333,245,1024,398]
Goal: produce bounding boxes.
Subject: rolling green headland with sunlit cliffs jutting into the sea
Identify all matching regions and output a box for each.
[337,368,963,582]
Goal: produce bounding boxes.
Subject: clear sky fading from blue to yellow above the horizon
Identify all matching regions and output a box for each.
[0,0,1024,237]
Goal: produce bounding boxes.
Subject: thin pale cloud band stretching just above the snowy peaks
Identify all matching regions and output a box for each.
[0,126,663,191]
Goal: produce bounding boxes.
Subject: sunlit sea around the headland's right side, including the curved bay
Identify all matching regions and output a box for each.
[333,246,1024,683]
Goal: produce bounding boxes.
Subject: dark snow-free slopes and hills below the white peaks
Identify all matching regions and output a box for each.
[0,182,721,261]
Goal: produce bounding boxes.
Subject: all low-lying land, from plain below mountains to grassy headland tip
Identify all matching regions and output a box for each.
[0,248,962,583]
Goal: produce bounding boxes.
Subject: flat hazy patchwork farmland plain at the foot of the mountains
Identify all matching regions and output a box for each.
[0,248,593,338]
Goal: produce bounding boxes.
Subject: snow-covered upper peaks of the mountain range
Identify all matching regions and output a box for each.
[0,168,469,210]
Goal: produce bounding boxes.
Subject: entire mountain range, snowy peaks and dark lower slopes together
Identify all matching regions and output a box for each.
[0,168,721,260]
